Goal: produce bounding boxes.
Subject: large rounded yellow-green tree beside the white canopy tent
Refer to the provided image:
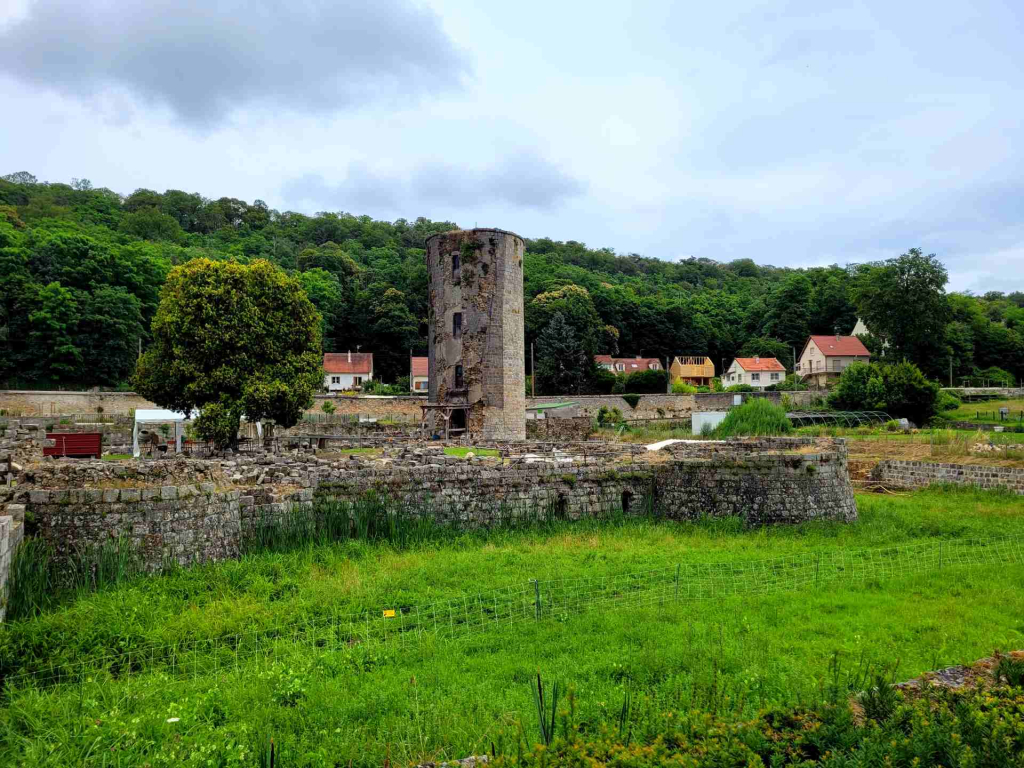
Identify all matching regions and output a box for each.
[135,259,324,446]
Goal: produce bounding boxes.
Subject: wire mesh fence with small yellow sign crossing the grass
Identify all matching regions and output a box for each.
[3,535,1024,692]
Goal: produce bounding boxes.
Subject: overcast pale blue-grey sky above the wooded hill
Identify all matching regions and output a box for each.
[0,0,1024,292]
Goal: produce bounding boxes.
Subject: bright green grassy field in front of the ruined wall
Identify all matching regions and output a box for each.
[0,490,1024,766]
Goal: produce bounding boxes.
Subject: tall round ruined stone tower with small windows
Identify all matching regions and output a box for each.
[427,229,526,440]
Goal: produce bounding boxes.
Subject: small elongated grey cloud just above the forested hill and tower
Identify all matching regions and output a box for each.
[282,154,586,212]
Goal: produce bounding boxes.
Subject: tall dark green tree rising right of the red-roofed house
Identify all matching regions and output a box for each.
[852,248,950,375]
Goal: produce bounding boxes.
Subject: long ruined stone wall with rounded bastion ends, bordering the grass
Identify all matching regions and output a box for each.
[5,442,857,581]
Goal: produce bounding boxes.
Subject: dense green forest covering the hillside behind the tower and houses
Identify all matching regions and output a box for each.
[0,172,1024,387]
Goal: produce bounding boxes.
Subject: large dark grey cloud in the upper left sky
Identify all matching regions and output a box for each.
[0,0,469,127]
